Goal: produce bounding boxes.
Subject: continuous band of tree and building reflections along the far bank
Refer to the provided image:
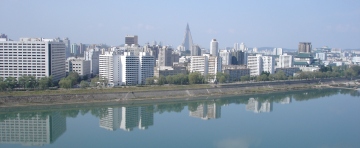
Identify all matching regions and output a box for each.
[0,89,360,146]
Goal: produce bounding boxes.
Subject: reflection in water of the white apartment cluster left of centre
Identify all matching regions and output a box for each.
[100,106,154,131]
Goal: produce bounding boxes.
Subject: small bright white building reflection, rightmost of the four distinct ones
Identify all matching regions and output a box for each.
[246,98,273,113]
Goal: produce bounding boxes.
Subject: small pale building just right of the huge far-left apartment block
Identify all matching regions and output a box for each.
[65,57,91,76]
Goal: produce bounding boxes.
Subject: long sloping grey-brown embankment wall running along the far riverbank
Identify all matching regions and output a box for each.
[0,78,349,107]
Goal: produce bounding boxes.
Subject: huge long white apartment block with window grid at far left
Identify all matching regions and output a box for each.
[0,38,66,81]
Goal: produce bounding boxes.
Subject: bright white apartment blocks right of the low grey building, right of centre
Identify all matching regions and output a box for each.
[247,54,275,76]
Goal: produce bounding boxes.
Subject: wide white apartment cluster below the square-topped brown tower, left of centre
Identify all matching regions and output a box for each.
[99,52,155,86]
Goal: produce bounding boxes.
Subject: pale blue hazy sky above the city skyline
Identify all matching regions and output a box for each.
[0,0,360,49]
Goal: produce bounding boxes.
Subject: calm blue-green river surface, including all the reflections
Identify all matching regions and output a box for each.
[0,89,360,148]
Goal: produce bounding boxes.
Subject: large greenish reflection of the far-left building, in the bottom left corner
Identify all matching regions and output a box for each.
[0,113,66,146]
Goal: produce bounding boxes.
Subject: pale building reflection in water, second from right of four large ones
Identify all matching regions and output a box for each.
[189,102,221,120]
